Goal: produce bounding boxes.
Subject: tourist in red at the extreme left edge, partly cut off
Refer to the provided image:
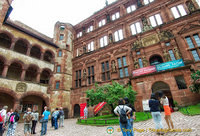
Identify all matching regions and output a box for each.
[0,106,8,136]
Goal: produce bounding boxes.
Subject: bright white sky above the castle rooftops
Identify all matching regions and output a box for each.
[10,0,116,38]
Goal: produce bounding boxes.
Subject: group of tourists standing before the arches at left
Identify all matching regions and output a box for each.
[0,106,64,136]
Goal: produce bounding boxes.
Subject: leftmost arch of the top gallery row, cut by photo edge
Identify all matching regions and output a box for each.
[0,32,12,49]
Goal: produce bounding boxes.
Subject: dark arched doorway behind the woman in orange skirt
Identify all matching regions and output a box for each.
[152,81,174,106]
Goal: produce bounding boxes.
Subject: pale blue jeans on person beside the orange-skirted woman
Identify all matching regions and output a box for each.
[151,111,163,129]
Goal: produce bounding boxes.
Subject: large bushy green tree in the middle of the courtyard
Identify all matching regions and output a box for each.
[86,81,136,113]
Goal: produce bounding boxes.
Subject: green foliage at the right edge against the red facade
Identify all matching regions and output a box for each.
[189,70,200,93]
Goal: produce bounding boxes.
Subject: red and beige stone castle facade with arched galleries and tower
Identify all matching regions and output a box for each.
[0,0,200,117]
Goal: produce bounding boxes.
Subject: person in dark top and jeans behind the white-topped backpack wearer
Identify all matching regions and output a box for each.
[124,97,136,136]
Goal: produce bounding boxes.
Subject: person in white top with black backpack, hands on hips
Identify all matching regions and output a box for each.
[114,99,132,136]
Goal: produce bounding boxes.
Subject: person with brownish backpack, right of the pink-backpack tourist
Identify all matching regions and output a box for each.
[23,108,33,136]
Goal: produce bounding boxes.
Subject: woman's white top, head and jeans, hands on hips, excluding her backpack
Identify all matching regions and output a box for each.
[114,99,132,136]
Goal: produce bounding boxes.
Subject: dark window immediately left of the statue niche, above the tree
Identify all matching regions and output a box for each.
[101,61,110,81]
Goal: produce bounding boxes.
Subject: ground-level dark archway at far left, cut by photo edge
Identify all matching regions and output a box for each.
[0,92,15,110]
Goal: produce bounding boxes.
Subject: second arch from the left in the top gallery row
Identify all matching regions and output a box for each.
[13,38,29,54]
